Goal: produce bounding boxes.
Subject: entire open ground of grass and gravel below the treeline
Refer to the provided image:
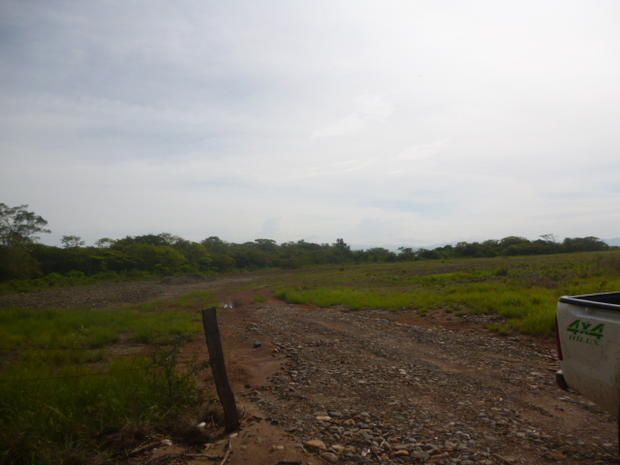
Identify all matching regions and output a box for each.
[0,251,620,465]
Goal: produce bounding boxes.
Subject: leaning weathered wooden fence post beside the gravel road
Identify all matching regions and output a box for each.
[202,307,239,432]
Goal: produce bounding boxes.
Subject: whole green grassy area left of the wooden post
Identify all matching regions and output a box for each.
[0,292,215,464]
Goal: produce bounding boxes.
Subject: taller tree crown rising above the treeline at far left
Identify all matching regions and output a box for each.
[0,203,51,246]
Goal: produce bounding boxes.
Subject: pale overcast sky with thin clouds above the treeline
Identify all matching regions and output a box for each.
[0,0,620,247]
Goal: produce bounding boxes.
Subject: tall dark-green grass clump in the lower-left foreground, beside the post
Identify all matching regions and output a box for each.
[0,348,206,465]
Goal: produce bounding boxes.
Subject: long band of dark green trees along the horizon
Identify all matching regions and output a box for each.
[0,233,610,280]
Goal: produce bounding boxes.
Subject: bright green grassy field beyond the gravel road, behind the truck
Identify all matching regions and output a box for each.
[271,251,620,335]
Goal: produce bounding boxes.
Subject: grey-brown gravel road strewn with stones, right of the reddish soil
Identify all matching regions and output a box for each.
[235,303,619,465]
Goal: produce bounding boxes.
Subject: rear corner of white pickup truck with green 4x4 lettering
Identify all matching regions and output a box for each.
[556,292,620,419]
